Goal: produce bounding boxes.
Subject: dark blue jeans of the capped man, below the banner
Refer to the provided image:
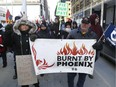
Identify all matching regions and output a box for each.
[68,73,87,87]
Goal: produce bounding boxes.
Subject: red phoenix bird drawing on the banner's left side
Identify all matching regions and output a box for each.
[32,44,55,70]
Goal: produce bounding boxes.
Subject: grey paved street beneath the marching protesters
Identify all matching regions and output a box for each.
[0,53,116,87]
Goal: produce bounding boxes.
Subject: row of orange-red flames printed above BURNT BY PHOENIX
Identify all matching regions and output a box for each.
[57,42,94,55]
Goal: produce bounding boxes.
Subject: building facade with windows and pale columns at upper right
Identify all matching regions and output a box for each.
[71,0,116,28]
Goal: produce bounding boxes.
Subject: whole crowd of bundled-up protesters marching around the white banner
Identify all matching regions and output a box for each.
[0,14,103,87]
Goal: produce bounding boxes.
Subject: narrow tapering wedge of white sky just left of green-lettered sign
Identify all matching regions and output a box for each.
[48,0,59,19]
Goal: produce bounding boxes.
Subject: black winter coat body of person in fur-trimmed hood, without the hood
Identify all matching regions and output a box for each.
[12,32,31,55]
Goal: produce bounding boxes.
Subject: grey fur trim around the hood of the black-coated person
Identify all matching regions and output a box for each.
[13,19,37,35]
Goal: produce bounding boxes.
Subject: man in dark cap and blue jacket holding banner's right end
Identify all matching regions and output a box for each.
[67,17,102,87]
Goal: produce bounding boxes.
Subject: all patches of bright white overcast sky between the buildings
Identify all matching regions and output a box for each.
[0,0,59,20]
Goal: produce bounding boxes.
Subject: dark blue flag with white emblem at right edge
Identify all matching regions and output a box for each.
[104,23,116,45]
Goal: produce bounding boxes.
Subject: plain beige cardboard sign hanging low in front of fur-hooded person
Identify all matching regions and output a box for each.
[16,55,37,85]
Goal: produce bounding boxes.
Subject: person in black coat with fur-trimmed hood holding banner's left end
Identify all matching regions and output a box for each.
[12,19,39,87]
